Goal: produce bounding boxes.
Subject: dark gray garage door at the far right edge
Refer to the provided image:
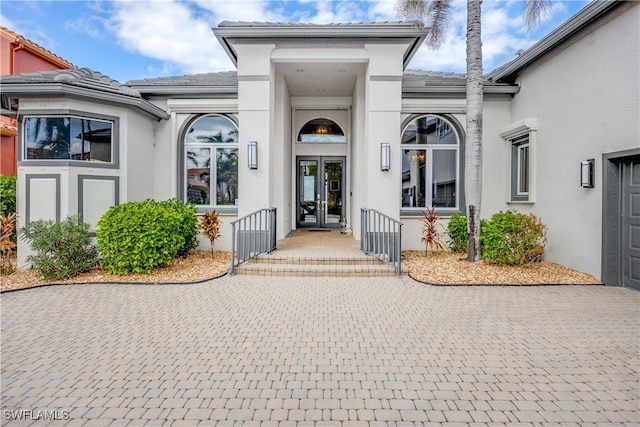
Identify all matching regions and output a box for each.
[621,156,640,289]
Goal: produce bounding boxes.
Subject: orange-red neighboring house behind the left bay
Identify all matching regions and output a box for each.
[0,27,75,176]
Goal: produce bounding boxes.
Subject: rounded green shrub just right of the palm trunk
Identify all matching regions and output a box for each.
[480,210,547,265]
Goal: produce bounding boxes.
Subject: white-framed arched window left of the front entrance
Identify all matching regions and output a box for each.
[184,115,238,206]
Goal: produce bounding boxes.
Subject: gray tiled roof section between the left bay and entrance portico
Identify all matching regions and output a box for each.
[125,71,238,95]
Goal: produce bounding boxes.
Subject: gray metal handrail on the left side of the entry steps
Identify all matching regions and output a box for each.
[230,208,276,275]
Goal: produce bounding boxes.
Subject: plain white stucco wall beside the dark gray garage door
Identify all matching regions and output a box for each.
[502,3,640,277]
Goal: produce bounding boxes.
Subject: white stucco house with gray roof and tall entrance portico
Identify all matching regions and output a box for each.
[1,2,640,288]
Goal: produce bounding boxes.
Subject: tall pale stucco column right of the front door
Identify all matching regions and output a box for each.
[365,45,406,218]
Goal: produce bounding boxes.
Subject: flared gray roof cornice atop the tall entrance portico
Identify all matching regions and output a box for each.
[212,21,429,67]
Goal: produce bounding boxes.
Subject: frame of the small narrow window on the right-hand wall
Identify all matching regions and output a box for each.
[500,118,538,203]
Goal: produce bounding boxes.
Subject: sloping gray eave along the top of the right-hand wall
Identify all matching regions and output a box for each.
[485,0,635,83]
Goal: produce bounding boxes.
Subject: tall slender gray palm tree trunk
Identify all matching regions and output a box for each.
[464,0,483,261]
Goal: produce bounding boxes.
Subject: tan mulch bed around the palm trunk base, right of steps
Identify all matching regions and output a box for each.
[402,251,602,285]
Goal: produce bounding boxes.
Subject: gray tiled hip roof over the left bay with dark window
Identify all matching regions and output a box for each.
[0,68,169,120]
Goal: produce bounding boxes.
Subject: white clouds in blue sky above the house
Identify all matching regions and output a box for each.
[60,0,584,75]
